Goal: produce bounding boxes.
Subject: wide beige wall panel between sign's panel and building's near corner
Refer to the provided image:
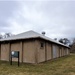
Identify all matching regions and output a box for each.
[23,41,36,63]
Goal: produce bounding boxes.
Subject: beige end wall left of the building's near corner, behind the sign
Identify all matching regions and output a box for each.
[0,41,36,63]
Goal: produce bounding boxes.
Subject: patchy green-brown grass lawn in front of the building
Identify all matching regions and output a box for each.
[0,54,75,75]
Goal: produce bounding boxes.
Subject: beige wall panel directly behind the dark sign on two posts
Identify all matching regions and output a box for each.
[11,42,22,62]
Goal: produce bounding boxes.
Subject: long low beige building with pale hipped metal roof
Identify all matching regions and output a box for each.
[0,31,69,63]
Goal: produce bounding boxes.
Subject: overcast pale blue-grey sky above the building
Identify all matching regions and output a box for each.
[0,0,75,38]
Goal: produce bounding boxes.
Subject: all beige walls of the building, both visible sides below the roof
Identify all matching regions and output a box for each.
[0,39,69,63]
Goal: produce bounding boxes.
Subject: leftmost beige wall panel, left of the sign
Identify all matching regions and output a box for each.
[1,43,10,61]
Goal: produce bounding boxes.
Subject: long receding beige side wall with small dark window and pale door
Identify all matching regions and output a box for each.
[37,41,69,62]
